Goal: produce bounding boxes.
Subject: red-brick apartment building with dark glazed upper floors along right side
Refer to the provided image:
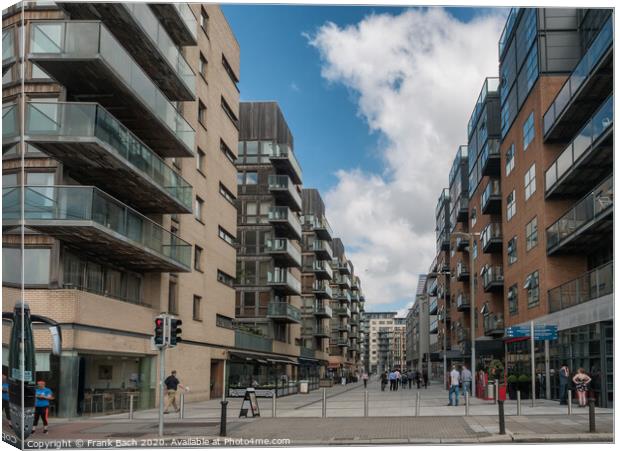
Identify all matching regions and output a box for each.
[418,8,613,406]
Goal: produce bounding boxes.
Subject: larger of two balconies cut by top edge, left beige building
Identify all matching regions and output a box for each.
[58,2,196,101]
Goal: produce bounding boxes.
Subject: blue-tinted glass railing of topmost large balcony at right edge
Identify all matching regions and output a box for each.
[543,15,614,135]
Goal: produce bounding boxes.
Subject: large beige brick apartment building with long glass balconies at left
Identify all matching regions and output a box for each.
[2,2,239,417]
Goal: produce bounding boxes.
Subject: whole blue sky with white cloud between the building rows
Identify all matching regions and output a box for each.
[222,5,508,315]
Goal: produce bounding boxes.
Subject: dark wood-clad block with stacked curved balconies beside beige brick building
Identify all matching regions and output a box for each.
[229,102,302,390]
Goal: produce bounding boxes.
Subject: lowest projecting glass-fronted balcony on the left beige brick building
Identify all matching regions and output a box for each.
[2,185,192,272]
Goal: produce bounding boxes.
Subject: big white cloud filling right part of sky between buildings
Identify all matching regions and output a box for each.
[309,8,505,309]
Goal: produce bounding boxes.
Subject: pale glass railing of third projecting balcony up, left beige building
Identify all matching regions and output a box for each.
[29,21,195,154]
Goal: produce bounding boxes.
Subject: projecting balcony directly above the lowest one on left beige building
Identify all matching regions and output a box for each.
[18,102,192,213]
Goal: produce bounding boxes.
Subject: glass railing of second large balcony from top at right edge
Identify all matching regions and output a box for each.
[545,94,614,191]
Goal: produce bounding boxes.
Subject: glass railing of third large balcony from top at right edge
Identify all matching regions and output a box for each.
[547,176,614,253]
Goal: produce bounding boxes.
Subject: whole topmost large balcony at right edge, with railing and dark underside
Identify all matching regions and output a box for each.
[543,14,613,142]
